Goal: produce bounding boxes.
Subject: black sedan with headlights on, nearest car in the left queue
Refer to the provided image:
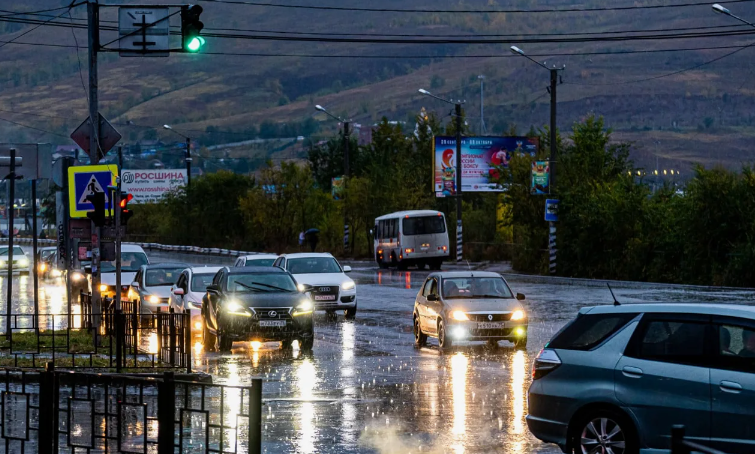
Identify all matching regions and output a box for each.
[202,267,314,352]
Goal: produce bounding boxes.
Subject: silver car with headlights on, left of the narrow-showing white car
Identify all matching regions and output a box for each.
[128,263,189,314]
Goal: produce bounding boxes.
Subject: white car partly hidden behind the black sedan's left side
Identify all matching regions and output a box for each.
[170,266,221,335]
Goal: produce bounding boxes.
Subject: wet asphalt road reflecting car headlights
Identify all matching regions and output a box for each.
[8,250,755,453]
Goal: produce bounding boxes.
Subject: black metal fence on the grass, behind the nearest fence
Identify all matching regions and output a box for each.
[0,295,192,372]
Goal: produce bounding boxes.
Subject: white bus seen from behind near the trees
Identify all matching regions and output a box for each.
[373,210,449,270]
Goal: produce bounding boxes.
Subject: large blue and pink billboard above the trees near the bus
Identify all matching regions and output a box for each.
[433,136,539,197]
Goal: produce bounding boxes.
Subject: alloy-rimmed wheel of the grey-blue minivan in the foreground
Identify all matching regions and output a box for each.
[572,410,639,454]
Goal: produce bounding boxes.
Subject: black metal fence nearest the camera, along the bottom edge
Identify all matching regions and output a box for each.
[0,369,262,454]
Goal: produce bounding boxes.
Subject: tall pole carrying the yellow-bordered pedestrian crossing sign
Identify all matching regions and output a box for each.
[87,0,102,329]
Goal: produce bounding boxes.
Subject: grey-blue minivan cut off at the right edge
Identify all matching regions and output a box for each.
[527,304,755,454]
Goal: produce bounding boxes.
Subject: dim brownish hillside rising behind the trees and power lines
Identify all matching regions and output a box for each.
[0,0,755,175]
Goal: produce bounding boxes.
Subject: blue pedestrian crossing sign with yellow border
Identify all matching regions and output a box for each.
[68,164,118,218]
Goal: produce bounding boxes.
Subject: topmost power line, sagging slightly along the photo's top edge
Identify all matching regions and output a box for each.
[204,0,752,14]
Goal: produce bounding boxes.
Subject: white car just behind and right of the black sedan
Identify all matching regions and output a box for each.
[274,252,357,319]
